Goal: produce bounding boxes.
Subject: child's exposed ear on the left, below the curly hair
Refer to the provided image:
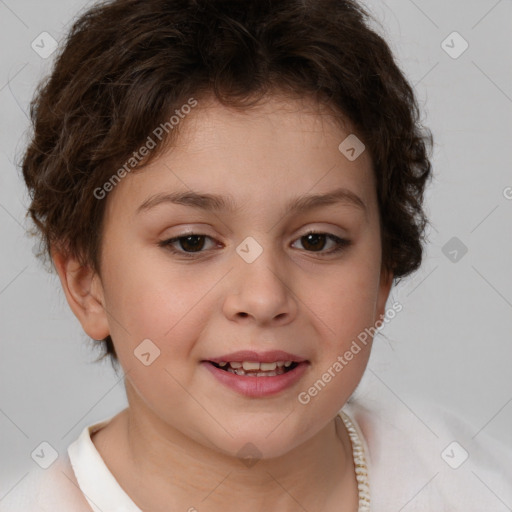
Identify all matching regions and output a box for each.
[52,251,110,340]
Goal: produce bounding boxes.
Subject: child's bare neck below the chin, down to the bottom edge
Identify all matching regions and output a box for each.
[97,382,357,512]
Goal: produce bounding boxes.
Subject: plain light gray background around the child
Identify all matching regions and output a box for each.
[0,0,512,499]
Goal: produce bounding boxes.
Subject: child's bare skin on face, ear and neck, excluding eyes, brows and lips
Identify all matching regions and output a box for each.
[54,95,392,511]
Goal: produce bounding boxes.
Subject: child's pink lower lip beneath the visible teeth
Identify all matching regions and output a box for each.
[201,361,309,398]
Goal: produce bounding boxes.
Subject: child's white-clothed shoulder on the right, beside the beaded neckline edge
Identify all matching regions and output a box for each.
[343,384,512,512]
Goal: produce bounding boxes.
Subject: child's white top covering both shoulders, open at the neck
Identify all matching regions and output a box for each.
[0,386,512,512]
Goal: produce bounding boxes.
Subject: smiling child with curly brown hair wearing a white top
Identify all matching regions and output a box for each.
[0,0,512,512]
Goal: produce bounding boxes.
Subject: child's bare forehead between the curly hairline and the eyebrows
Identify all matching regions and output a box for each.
[106,96,374,222]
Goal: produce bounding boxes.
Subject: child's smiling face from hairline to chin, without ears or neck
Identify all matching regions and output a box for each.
[90,97,390,457]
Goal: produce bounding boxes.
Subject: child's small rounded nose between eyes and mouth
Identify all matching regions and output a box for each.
[223,242,298,325]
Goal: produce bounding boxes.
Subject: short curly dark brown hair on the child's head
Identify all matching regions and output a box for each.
[21,0,432,361]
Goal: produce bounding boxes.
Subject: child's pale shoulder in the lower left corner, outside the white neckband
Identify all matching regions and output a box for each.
[0,453,90,512]
